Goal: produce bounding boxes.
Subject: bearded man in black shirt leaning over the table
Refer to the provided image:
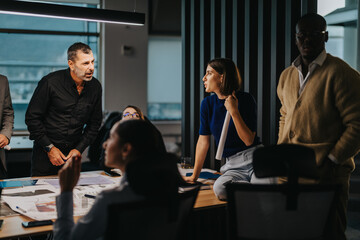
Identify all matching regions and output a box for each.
[25,42,102,176]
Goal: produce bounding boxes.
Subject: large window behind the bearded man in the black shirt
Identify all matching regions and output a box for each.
[0,1,99,131]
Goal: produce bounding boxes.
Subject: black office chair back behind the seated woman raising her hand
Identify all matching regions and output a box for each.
[105,185,200,240]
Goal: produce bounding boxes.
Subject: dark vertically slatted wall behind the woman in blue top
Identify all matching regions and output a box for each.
[181,0,316,168]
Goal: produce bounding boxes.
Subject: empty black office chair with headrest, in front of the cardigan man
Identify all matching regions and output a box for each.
[226,144,339,240]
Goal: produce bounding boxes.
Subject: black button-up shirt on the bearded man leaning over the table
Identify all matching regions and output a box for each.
[25,69,102,152]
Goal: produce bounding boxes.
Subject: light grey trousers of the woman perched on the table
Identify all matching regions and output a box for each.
[213,145,276,200]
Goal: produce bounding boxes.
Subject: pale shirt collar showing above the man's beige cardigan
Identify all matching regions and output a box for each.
[292,49,327,95]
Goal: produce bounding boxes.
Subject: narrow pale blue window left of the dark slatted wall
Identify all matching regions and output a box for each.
[148,36,181,120]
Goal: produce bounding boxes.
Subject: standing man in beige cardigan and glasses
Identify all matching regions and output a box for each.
[277,14,360,240]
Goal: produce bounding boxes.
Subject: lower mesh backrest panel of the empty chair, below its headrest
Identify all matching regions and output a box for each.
[226,183,338,240]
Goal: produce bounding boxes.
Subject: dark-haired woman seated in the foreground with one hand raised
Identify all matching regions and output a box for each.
[54,120,181,239]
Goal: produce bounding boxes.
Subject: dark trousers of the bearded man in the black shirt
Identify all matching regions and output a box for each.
[31,143,72,177]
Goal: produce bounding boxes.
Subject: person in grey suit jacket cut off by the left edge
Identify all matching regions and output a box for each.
[0,75,14,179]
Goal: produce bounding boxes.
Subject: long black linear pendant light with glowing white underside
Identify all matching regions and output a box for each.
[0,0,145,26]
